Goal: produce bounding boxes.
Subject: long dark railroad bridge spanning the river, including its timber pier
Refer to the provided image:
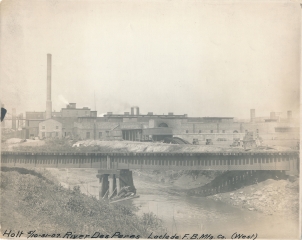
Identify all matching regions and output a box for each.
[1,150,299,199]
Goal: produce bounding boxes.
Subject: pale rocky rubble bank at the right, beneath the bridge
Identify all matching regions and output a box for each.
[207,179,299,218]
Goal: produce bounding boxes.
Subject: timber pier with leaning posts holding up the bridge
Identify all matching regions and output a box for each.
[96,169,136,200]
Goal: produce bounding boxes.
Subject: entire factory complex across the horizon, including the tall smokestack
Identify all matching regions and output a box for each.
[2,54,299,143]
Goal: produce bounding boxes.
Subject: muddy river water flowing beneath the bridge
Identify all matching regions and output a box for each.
[53,171,298,239]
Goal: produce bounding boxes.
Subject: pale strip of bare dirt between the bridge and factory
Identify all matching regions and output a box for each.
[2,138,291,153]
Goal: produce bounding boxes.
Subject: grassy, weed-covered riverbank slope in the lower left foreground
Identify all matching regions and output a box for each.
[0,171,161,237]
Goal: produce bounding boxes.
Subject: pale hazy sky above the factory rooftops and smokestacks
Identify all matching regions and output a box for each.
[0,0,301,118]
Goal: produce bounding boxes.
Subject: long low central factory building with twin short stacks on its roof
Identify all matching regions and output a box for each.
[75,107,243,141]
